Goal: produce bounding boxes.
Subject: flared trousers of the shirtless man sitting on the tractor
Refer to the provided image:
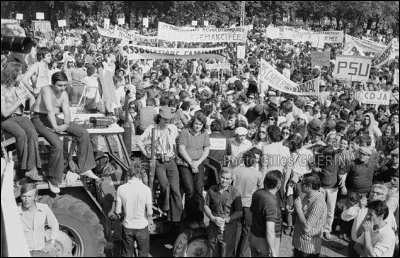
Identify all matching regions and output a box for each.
[32,114,96,185]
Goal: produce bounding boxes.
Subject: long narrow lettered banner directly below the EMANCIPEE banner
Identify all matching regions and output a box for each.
[127,44,226,56]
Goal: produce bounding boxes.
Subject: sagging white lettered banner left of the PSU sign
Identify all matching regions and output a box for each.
[260,59,319,96]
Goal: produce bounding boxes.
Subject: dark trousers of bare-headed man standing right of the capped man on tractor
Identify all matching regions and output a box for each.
[178,163,204,222]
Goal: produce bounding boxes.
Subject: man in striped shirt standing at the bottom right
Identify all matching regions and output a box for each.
[293,173,327,257]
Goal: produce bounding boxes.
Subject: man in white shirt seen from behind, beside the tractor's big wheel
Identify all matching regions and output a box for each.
[115,163,153,257]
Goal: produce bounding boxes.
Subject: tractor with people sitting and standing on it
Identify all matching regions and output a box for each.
[1,114,220,257]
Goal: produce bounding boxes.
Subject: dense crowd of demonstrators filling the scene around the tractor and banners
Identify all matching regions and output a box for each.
[1,19,399,257]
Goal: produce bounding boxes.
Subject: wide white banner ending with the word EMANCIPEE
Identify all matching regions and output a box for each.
[158,22,247,43]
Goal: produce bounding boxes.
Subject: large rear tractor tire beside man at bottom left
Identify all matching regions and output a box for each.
[40,195,106,257]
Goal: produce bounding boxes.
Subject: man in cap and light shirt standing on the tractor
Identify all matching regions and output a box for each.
[137,107,183,222]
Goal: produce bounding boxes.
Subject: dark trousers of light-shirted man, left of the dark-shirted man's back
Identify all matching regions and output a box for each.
[236,207,252,257]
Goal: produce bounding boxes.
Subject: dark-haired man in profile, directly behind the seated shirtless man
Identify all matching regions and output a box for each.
[22,47,51,97]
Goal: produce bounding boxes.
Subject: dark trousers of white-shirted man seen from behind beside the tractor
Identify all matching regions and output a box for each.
[122,227,150,257]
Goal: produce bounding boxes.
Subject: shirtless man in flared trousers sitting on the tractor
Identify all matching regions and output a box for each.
[31,72,99,193]
